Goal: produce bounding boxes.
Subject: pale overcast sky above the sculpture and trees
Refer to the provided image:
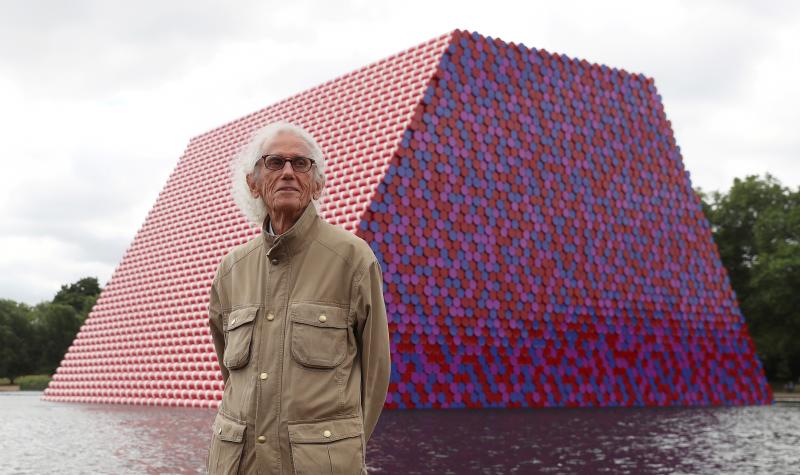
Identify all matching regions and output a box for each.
[0,0,800,304]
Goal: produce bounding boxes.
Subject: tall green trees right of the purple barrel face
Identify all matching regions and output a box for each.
[698,174,800,380]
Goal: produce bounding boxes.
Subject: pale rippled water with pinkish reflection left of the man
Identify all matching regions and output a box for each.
[0,392,214,474]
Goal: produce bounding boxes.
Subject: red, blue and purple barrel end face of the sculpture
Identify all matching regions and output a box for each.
[358,33,772,407]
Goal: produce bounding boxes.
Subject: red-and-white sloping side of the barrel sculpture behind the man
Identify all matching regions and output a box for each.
[44,34,452,407]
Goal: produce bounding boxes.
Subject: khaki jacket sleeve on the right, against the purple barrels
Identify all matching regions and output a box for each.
[353,260,391,441]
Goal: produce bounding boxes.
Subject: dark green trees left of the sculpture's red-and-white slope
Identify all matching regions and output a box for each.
[0,277,102,384]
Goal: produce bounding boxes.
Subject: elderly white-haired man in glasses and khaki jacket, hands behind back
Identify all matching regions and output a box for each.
[208,122,390,475]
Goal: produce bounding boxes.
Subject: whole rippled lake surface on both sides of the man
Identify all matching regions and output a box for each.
[0,392,800,474]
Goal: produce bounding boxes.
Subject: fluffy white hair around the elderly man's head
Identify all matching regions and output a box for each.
[231,121,325,226]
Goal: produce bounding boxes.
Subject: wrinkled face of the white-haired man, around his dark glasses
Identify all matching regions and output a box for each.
[247,132,322,220]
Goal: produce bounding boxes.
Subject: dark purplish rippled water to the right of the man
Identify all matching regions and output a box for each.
[368,406,800,474]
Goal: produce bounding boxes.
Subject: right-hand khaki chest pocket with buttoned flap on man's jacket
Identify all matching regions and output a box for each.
[290,303,348,369]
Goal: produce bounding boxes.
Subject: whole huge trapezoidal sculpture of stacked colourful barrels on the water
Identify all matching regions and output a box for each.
[44,31,772,408]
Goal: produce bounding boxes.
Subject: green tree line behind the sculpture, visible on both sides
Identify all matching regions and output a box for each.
[0,174,800,382]
